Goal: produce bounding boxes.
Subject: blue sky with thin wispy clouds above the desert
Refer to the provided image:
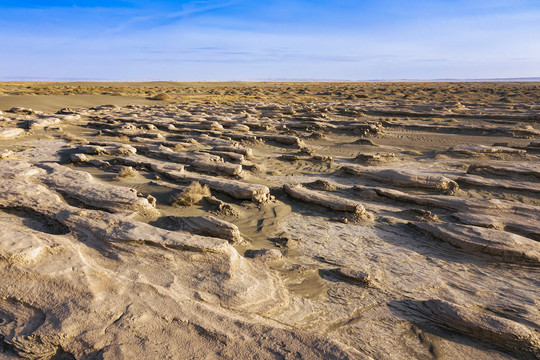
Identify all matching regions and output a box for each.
[0,0,540,81]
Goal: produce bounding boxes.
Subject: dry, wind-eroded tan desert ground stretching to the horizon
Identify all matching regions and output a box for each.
[0,83,540,359]
